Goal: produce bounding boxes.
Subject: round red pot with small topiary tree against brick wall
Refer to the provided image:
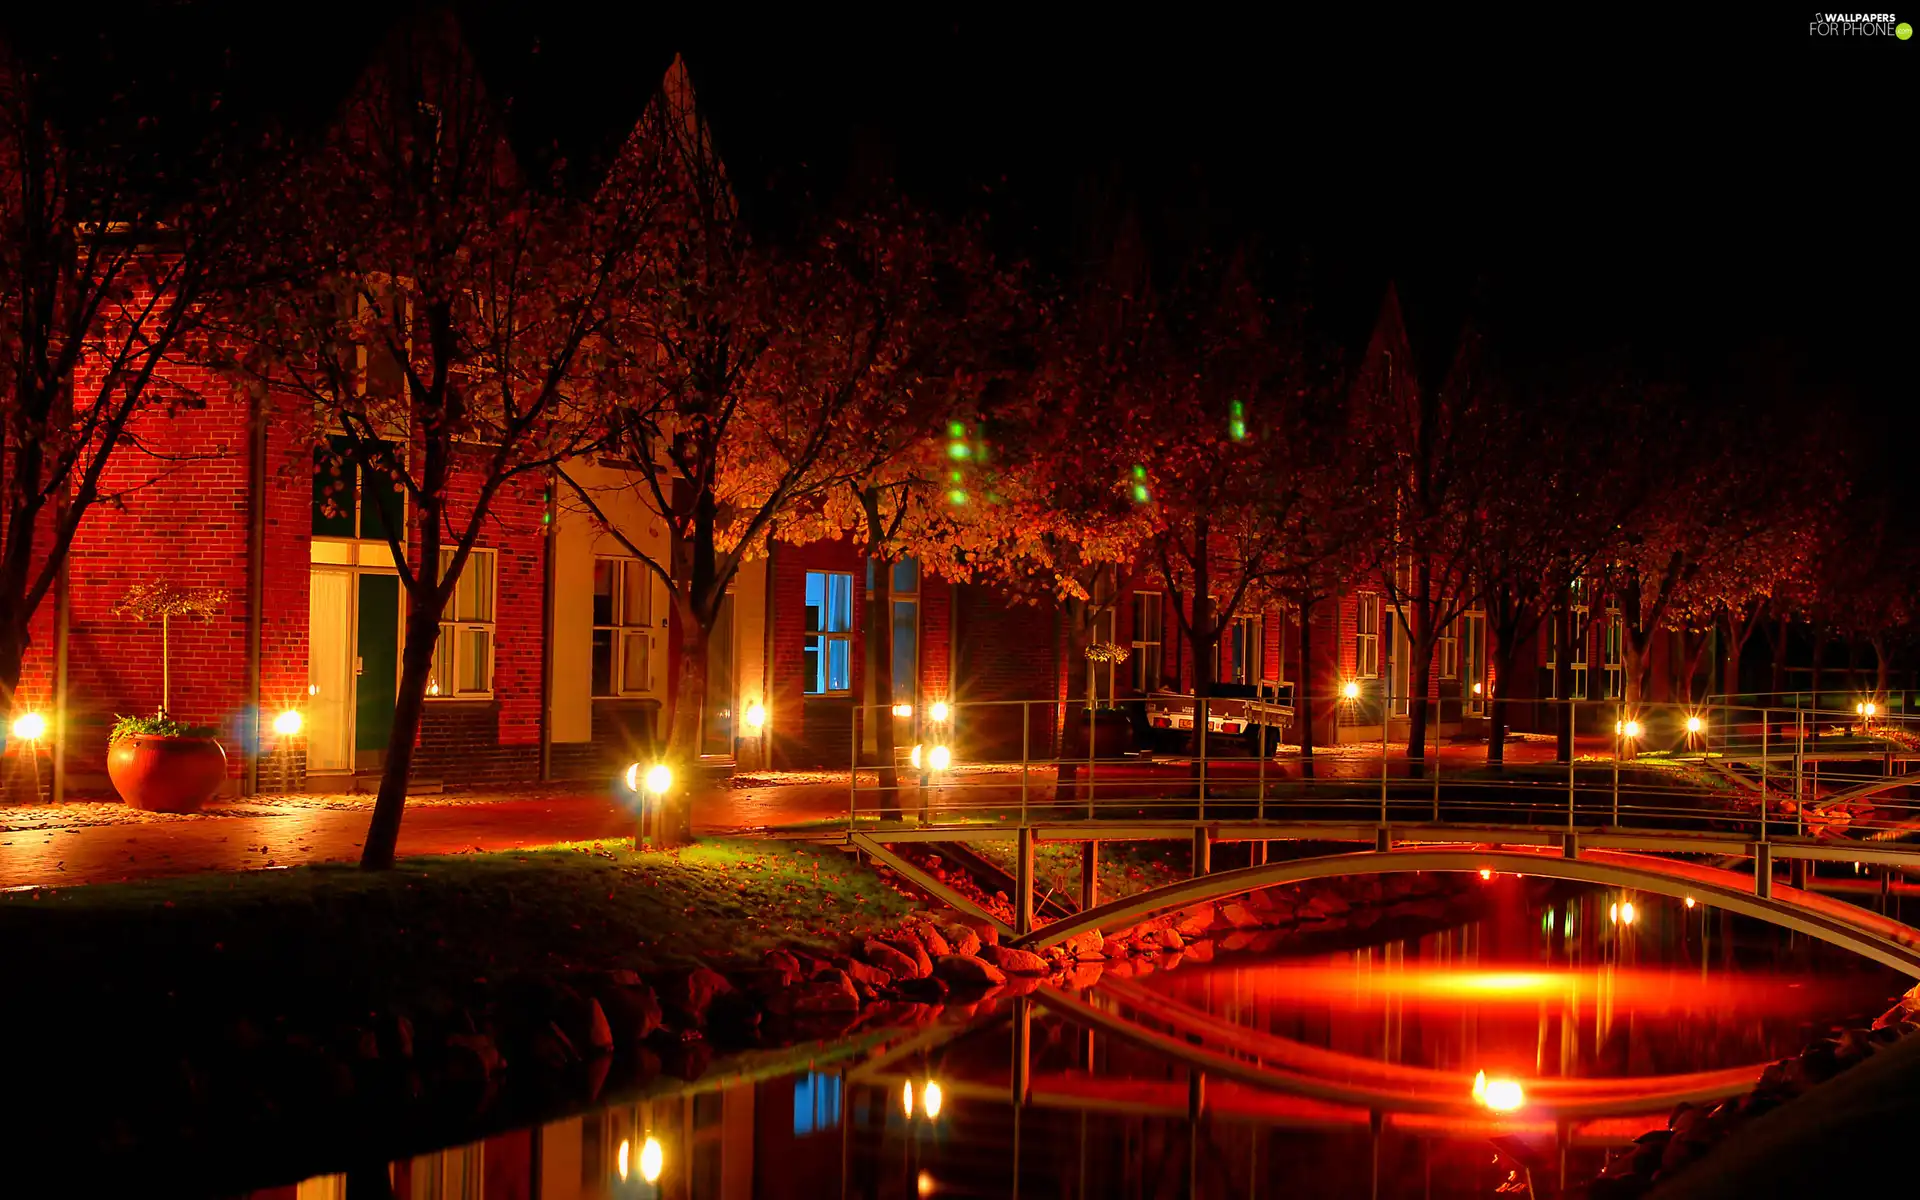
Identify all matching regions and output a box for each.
[108,580,227,812]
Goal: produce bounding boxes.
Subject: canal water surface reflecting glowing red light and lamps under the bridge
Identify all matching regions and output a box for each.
[255,879,1905,1200]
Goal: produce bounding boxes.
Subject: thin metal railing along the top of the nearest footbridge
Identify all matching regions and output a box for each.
[843,687,1920,841]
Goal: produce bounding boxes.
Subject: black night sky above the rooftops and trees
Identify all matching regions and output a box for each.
[10,0,1920,430]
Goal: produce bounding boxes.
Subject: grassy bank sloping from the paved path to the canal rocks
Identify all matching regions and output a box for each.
[0,841,929,1020]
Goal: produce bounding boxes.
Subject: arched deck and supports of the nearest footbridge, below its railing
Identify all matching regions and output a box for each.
[840,814,1920,977]
